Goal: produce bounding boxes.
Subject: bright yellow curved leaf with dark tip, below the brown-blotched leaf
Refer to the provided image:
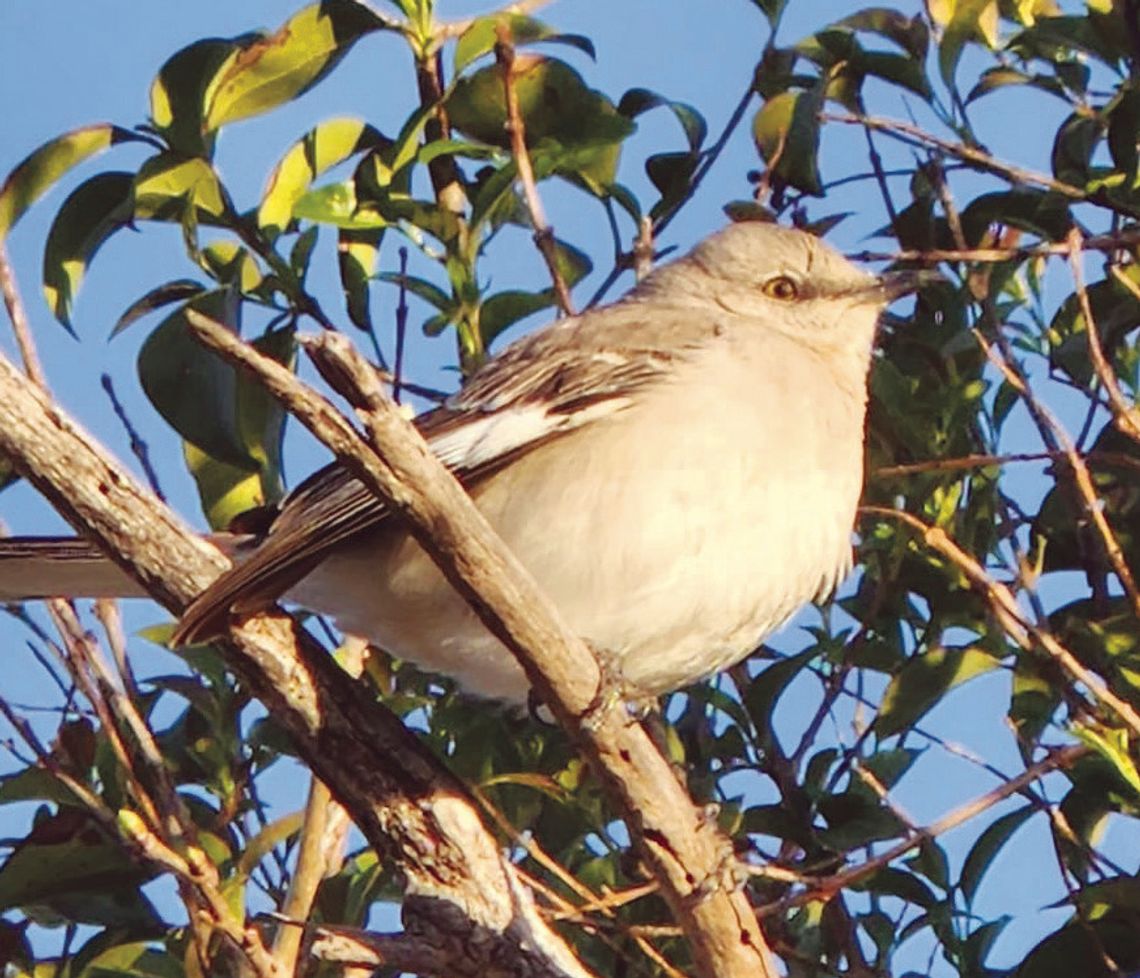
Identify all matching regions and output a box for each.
[258,119,391,236]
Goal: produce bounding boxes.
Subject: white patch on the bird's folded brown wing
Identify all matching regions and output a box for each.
[429,398,629,472]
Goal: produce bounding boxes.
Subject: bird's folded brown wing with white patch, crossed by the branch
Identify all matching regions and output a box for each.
[174,303,677,644]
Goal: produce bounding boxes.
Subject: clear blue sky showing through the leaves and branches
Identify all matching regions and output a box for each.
[0,0,1124,967]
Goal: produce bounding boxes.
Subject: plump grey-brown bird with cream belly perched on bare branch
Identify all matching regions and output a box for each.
[0,221,922,704]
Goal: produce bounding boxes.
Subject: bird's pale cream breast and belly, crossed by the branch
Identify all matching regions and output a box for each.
[292,336,864,701]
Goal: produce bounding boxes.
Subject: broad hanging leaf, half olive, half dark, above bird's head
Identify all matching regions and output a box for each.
[752,84,824,197]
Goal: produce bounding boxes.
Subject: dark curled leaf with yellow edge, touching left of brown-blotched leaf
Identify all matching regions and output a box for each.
[150,34,251,157]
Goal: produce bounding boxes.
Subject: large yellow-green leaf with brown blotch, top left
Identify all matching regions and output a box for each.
[204,0,388,132]
